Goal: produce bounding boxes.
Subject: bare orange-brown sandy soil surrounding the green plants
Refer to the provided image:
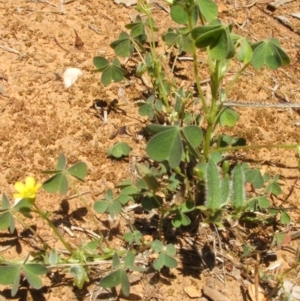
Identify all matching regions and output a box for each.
[0,0,300,301]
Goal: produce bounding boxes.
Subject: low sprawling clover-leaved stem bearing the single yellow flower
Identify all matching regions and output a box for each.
[0,154,144,296]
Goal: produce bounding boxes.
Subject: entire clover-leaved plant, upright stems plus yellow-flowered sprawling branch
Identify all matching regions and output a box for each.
[0,0,300,296]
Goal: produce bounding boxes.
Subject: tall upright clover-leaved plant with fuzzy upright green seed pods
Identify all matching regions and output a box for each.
[94,0,298,294]
